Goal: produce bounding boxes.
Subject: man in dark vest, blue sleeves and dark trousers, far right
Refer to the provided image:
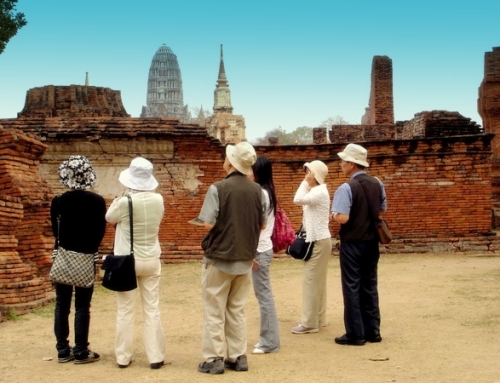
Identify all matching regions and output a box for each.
[331,144,387,346]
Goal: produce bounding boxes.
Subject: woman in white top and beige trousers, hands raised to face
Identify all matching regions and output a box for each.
[292,160,332,334]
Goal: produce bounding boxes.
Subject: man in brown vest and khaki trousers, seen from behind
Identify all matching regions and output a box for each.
[197,142,266,374]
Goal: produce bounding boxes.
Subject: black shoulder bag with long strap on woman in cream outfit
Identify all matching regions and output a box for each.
[101,196,137,291]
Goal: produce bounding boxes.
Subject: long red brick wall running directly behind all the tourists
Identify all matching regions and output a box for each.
[2,118,493,262]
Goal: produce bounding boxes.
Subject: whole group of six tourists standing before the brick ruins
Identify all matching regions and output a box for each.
[51,142,386,374]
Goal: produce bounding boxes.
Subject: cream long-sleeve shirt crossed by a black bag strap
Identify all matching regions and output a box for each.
[106,192,164,258]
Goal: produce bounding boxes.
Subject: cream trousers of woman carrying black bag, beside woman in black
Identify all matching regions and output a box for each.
[115,258,165,365]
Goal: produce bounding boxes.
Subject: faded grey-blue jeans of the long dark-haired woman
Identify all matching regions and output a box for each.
[252,249,280,352]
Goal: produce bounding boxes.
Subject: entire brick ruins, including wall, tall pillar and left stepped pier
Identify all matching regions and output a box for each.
[0,48,500,318]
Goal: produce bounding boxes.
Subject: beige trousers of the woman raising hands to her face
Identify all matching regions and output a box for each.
[300,238,332,328]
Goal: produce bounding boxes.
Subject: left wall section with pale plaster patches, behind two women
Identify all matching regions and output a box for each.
[4,117,229,261]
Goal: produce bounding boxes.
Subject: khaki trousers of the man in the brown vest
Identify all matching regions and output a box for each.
[201,263,251,361]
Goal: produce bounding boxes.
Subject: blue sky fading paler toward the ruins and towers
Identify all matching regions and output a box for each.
[0,0,500,140]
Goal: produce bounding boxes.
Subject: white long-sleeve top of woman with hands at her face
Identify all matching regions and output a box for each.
[293,181,331,242]
